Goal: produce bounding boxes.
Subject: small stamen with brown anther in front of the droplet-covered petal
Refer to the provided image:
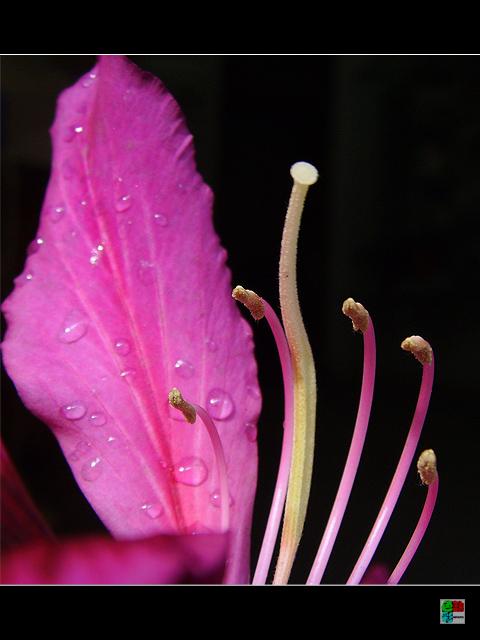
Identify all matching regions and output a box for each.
[168,388,230,532]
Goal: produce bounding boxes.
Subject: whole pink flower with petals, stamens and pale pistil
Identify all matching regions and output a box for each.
[2,55,438,584]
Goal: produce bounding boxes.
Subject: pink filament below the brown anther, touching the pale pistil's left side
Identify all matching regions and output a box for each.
[252,299,294,585]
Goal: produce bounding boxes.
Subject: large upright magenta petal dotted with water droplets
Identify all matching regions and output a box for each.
[2,56,260,581]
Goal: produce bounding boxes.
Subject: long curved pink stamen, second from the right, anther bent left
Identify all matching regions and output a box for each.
[347,336,434,584]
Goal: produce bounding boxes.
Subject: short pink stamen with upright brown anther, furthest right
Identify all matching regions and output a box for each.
[387,449,438,584]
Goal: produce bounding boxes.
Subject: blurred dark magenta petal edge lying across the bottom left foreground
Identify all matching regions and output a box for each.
[1,534,228,585]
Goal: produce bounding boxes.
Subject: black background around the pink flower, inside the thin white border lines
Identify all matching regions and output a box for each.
[2,54,480,584]
